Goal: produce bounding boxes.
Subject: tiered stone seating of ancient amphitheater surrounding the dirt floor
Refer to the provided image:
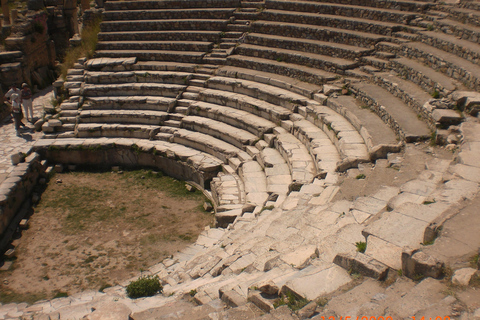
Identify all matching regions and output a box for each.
[0,0,480,320]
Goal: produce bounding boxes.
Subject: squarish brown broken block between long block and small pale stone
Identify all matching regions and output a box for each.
[402,249,445,279]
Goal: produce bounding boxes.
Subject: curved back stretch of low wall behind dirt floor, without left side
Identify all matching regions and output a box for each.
[32,137,223,187]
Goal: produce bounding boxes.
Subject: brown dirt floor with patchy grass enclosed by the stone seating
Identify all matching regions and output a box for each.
[0,171,213,303]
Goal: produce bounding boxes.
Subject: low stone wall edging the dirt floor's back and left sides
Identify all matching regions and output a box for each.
[0,138,222,251]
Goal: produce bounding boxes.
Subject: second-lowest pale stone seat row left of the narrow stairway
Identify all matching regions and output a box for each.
[78,110,169,126]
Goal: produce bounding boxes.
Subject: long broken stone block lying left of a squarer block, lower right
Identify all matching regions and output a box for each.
[333,252,388,280]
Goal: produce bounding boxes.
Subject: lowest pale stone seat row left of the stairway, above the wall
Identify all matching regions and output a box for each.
[75,123,160,140]
